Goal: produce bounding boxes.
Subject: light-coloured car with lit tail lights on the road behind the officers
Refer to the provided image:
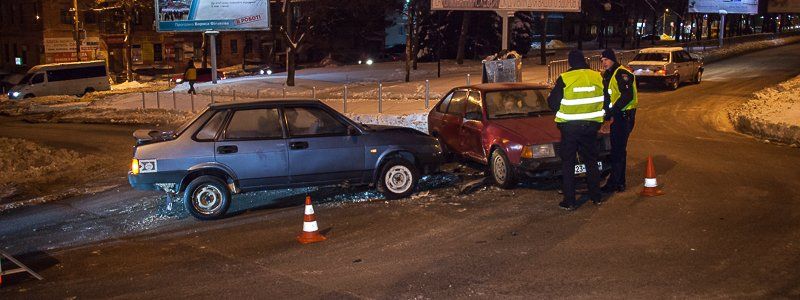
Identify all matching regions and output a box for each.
[628,47,703,90]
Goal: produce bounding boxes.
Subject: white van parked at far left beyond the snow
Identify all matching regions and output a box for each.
[8,60,111,99]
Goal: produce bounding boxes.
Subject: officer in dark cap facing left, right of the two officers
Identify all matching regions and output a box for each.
[600,49,639,193]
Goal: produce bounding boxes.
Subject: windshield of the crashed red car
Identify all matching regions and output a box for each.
[486,89,550,119]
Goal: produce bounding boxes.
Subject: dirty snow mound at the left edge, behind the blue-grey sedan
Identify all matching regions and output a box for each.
[0,138,87,200]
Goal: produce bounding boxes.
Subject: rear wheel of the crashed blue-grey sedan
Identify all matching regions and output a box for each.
[183,176,231,220]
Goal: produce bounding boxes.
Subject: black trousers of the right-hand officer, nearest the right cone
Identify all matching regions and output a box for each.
[606,109,636,186]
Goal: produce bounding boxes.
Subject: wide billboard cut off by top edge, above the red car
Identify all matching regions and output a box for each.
[431,0,581,12]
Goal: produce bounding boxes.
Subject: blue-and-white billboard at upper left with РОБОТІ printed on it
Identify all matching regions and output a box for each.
[155,0,270,32]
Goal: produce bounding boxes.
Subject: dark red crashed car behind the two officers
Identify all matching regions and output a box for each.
[428,83,611,188]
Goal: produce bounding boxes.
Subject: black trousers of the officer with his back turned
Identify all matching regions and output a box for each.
[558,121,601,204]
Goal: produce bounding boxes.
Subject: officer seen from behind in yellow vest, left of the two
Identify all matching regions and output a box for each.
[547,50,605,210]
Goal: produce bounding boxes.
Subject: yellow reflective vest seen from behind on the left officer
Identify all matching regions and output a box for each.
[555,69,605,123]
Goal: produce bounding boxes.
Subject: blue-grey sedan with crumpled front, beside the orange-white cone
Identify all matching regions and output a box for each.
[128,99,442,219]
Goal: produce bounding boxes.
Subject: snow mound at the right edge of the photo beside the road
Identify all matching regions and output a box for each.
[728,76,800,145]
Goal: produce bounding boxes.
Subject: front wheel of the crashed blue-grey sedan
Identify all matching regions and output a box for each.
[375,157,419,200]
